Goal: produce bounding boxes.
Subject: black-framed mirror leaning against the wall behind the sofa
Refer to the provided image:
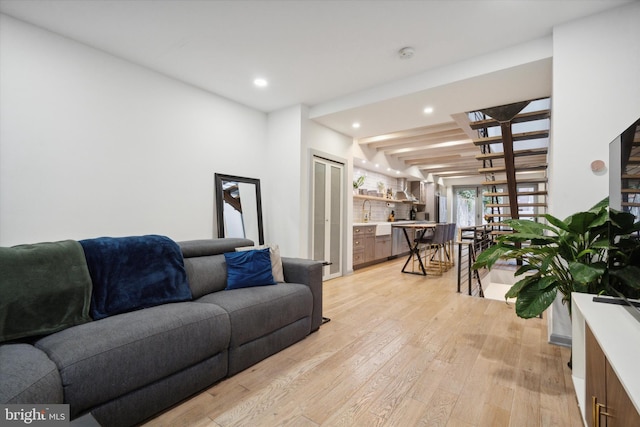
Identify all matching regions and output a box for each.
[215,173,264,245]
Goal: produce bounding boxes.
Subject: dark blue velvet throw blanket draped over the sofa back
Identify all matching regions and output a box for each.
[80,235,191,320]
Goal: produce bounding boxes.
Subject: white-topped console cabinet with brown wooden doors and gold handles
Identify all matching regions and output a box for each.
[572,293,640,427]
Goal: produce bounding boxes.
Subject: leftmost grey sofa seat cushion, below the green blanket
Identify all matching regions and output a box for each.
[0,344,64,404]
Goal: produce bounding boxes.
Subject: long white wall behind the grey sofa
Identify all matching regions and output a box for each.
[0,15,264,246]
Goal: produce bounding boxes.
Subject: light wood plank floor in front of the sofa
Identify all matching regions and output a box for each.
[146,259,582,427]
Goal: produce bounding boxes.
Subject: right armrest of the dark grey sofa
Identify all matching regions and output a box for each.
[282,257,322,332]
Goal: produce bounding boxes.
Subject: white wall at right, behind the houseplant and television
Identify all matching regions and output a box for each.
[549,3,640,340]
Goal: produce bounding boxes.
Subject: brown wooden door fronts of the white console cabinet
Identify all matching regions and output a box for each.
[585,325,640,427]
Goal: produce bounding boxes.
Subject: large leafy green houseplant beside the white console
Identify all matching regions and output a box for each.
[473,199,640,318]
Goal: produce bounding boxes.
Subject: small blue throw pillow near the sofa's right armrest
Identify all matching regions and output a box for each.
[224,248,276,290]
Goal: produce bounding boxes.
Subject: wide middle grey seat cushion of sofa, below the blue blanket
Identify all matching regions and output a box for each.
[35,302,230,416]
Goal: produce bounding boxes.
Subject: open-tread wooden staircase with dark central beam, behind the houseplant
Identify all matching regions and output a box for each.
[458,98,551,300]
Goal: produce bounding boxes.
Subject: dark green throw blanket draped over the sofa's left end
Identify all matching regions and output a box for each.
[0,240,91,342]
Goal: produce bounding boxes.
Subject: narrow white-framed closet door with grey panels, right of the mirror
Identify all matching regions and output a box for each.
[311,156,344,280]
